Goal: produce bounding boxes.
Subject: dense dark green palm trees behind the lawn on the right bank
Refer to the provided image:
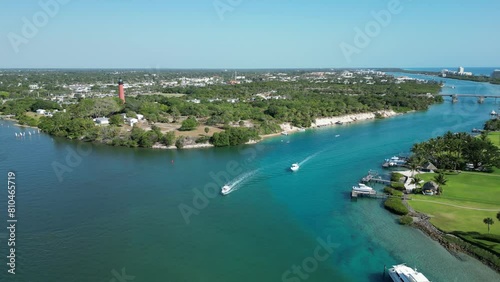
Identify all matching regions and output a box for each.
[412,132,500,171]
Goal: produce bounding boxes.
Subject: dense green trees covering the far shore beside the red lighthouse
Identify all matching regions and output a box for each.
[0,75,442,150]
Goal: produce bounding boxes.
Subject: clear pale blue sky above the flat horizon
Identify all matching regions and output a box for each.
[0,0,500,68]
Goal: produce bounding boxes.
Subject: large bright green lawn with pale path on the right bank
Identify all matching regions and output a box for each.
[409,170,500,235]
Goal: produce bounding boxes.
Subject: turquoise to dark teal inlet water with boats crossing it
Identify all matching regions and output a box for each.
[0,76,500,282]
